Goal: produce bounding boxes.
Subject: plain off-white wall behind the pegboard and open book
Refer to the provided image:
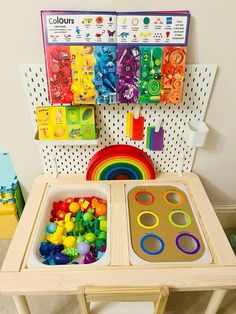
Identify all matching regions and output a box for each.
[0,0,236,204]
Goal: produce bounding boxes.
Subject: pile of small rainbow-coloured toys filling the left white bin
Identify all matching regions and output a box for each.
[39,196,107,265]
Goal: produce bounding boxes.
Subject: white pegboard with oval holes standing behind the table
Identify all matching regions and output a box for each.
[21,64,217,174]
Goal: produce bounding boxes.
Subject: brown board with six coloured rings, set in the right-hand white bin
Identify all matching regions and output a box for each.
[128,184,212,264]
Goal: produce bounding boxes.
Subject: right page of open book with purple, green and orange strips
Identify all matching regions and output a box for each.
[117,11,190,104]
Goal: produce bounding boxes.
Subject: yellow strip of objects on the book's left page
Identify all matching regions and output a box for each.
[70,46,97,104]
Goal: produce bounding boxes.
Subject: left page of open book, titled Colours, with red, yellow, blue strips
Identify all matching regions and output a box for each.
[42,11,117,104]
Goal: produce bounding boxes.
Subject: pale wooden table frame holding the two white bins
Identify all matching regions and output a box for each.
[0,173,236,314]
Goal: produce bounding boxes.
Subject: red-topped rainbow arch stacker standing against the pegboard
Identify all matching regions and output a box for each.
[86,145,156,180]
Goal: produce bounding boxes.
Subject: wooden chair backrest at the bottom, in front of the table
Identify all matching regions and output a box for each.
[77,287,169,314]
